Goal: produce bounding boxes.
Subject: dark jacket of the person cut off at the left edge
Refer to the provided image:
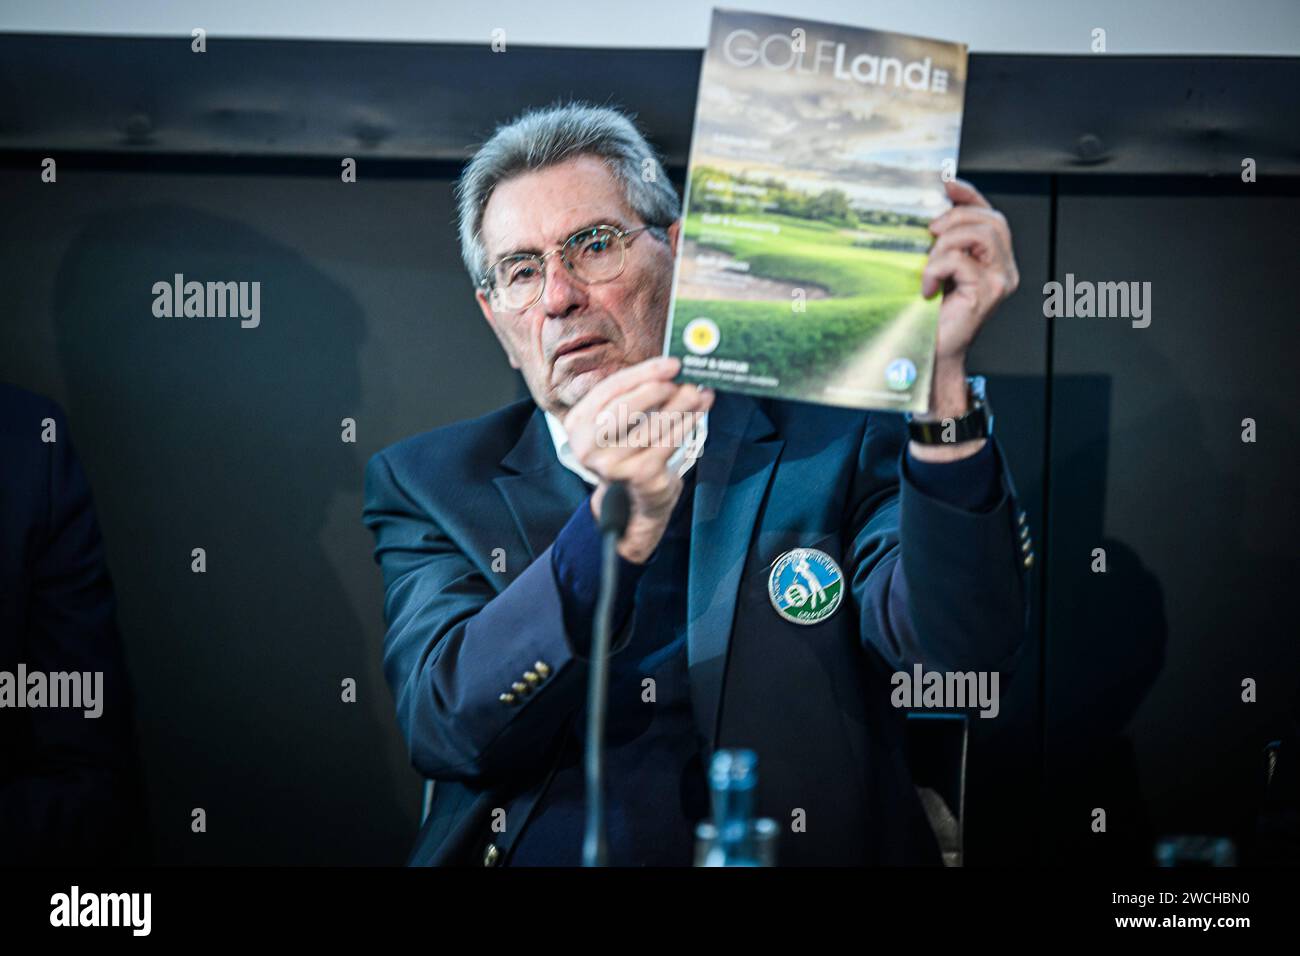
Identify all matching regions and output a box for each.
[0,385,140,865]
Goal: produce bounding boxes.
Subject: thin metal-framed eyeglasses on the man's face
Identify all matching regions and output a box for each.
[478,225,653,312]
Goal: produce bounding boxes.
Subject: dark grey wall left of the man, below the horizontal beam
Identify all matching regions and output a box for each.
[0,169,516,862]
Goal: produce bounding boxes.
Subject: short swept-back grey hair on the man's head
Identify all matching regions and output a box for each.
[456,103,681,285]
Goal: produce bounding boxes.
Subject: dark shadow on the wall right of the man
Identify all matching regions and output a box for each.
[1041,376,1169,866]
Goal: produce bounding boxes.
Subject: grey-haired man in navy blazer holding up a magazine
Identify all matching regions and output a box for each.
[365,104,1032,866]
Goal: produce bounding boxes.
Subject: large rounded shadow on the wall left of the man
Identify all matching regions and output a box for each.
[56,206,419,864]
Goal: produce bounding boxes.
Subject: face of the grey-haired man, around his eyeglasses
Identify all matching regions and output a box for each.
[477,156,680,418]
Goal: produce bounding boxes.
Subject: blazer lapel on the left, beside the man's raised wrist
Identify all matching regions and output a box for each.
[493,410,590,562]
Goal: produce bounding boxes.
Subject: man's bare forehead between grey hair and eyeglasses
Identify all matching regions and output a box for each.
[482,157,633,259]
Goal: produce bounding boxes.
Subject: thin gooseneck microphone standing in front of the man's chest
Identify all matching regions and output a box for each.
[582,481,632,866]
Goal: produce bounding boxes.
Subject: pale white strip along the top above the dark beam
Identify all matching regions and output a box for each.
[0,0,1300,56]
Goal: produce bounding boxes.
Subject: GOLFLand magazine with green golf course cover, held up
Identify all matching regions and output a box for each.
[664,10,966,412]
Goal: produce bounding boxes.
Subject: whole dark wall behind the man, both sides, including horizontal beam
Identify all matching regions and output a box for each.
[0,36,1300,864]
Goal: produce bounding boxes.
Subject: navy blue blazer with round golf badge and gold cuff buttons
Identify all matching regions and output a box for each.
[364,393,1028,865]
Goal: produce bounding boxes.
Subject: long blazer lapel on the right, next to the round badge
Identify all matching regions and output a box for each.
[686,393,785,753]
